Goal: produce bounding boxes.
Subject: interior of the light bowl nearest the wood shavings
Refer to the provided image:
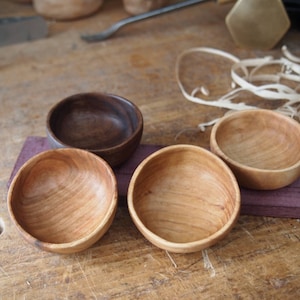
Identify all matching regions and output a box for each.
[215,110,300,170]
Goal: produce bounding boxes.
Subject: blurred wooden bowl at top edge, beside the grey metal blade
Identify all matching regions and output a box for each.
[33,0,103,20]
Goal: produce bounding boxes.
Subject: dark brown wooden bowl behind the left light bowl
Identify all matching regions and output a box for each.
[47,93,143,167]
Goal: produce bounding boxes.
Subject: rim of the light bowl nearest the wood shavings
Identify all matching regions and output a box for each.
[210,108,300,174]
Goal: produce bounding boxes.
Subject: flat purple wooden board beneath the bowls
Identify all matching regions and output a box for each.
[8,136,300,218]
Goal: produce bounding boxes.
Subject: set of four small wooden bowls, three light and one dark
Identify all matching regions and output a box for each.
[8,93,300,253]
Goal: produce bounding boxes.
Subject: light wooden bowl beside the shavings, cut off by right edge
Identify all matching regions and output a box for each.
[210,109,300,190]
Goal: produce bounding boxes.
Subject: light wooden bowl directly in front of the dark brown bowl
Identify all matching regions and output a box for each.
[7,148,117,254]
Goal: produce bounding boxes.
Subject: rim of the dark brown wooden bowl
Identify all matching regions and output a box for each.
[46,92,144,153]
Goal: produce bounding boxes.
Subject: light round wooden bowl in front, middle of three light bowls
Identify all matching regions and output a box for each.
[128,145,240,253]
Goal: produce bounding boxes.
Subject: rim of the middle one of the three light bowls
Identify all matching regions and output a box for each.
[127,144,241,253]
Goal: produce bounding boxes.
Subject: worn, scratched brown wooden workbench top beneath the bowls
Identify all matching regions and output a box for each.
[0,0,300,299]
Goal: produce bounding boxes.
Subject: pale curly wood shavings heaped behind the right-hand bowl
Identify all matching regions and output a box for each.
[175,46,300,130]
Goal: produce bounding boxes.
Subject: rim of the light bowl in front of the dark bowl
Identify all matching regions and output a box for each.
[7,148,118,253]
